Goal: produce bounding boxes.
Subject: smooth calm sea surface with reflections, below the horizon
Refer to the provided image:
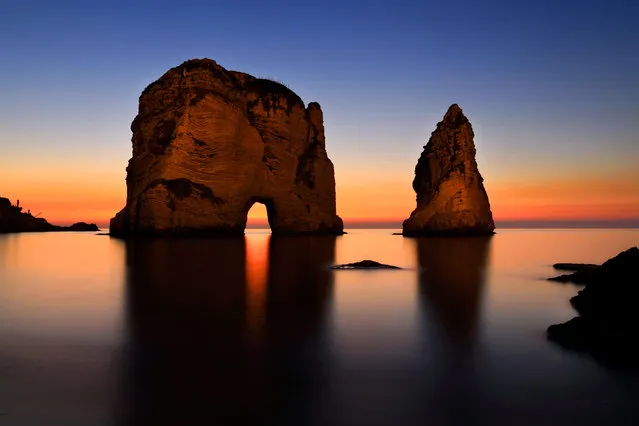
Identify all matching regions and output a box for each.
[0,229,639,426]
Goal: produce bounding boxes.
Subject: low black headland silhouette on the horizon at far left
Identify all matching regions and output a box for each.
[0,198,99,234]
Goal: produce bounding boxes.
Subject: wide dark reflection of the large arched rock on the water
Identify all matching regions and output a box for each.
[118,237,335,425]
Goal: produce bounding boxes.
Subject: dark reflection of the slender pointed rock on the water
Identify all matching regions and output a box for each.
[416,237,490,424]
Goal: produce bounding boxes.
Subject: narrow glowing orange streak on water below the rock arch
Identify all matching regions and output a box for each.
[245,233,271,334]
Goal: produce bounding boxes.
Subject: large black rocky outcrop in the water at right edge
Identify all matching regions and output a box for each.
[548,247,639,368]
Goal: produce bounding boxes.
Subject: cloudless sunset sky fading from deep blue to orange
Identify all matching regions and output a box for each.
[0,0,639,225]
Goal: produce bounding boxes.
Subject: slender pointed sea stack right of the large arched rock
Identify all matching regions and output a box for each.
[403,104,495,235]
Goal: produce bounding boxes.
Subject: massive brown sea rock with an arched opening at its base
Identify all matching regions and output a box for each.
[110,59,343,236]
